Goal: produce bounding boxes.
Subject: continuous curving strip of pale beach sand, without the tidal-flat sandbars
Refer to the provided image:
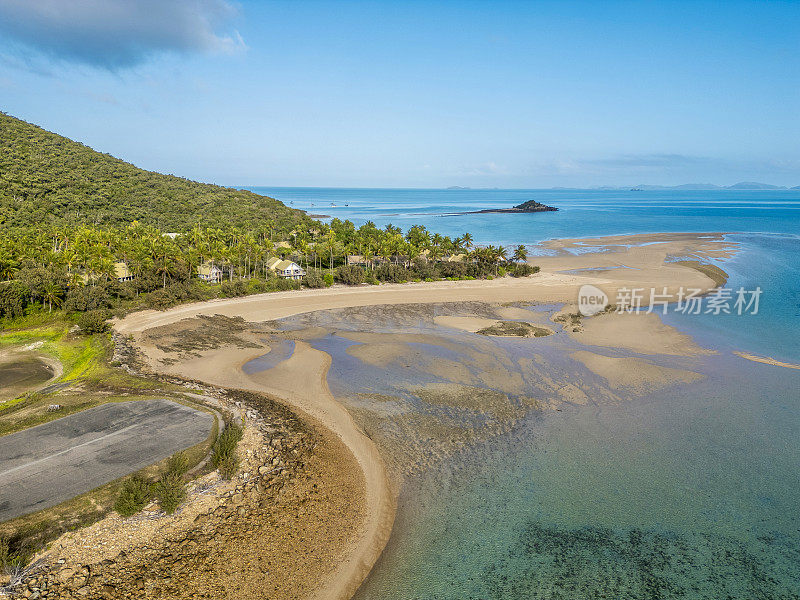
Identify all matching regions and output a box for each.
[115,234,733,598]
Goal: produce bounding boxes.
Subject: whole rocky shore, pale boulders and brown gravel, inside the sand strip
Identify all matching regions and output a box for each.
[0,358,363,600]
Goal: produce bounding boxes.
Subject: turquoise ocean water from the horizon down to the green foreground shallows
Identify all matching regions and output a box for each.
[245,188,800,600]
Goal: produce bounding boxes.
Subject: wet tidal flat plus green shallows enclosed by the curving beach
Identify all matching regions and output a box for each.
[245,303,800,600]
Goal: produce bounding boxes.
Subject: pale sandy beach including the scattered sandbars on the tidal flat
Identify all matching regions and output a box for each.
[114,234,735,599]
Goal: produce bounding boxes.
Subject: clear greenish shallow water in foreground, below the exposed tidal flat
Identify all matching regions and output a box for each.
[356,352,800,600]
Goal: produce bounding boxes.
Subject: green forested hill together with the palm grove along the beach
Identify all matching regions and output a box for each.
[0,115,537,331]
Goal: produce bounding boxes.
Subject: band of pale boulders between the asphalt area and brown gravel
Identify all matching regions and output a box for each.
[6,392,316,600]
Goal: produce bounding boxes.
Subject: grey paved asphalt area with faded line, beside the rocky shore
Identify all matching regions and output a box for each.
[0,400,214,521]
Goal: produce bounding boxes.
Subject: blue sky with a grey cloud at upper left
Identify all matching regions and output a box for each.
[0,0,800,187]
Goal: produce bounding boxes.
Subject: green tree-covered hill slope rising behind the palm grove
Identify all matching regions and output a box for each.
[0,113,311,232]
